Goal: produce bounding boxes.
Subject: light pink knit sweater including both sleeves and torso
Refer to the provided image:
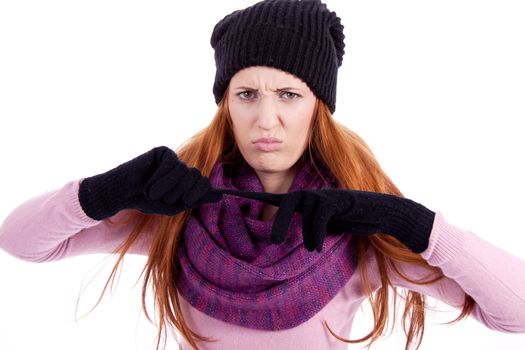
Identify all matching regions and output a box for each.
[0,179,525,350]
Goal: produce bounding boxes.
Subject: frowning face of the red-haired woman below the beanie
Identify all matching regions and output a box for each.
[228,66,316,180]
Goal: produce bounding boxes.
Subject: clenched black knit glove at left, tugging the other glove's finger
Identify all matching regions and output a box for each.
[78,146,222,220]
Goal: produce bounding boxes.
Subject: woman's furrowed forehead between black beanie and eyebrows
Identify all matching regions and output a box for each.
[230,66,307,88]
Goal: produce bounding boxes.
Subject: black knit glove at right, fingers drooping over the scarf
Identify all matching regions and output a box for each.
[271,189,435,253]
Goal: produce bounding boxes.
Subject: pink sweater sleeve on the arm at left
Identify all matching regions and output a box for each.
[0,179,151,262]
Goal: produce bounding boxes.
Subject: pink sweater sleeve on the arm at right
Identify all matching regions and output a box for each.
[390,212,525,333]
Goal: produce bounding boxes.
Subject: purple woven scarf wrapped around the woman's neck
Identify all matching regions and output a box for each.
[177,162,356,330]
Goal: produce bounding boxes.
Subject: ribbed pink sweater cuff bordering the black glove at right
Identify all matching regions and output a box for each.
[421,212,465,266]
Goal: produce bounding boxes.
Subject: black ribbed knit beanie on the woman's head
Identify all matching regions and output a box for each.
[210,0,345,113]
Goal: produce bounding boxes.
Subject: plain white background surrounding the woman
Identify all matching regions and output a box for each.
[0,0,525,350]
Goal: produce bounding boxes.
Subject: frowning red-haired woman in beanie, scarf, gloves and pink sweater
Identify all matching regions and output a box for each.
[0,0,525,349]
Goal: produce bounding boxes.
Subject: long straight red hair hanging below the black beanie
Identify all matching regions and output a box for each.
[89,91,475,350]
